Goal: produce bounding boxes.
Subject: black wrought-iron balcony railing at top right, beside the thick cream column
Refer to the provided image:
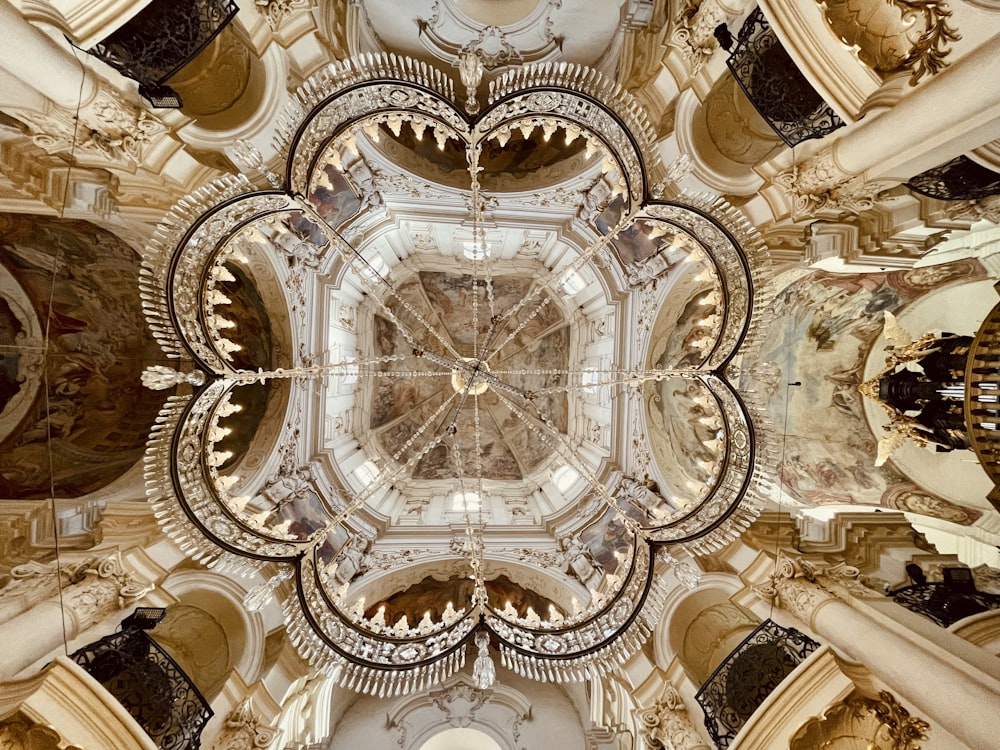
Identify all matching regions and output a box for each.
[726,8,844,146]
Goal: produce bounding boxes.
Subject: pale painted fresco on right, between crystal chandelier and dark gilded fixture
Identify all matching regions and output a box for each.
[744,260,986,524]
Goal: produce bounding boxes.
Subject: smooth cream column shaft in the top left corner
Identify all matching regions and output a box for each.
[0,0,98,108]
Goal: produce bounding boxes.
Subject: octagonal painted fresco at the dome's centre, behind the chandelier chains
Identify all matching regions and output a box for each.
[371,271,569,480]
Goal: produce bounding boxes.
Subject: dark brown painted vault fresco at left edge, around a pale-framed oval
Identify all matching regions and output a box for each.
[0,214,163,499]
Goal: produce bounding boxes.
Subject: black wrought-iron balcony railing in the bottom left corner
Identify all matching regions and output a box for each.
[70,628,213,750]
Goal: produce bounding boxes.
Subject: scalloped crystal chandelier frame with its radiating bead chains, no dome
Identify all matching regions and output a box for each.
[141,55,773,695]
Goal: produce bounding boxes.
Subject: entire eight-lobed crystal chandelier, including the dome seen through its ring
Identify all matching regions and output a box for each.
[141,55,772,695]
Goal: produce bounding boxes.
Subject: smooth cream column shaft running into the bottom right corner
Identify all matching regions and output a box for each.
[773,577,1000,748]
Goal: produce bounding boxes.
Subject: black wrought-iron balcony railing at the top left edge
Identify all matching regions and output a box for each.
[88,0,239,106]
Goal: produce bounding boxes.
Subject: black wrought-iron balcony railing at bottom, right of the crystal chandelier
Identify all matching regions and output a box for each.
[695,620,819,750]
